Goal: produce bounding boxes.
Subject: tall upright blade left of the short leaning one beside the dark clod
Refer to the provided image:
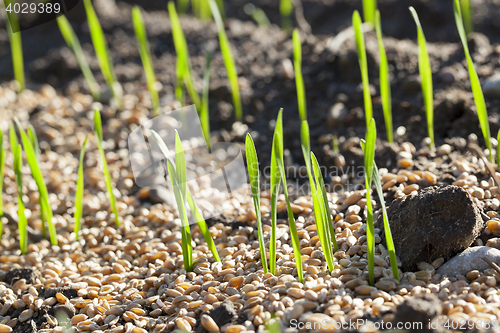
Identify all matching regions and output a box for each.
[364,119,377,286]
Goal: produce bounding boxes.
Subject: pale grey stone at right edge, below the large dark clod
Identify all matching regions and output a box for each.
[437,246,500,276]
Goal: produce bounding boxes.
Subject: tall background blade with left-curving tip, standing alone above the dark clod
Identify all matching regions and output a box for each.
[410,7,435,150]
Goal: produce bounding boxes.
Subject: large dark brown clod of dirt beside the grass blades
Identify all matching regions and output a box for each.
[379,185,484,271]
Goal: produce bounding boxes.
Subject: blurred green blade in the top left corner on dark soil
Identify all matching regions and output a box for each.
[4,0,26,92]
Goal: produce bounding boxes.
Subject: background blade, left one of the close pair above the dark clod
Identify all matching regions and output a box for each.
[352,10,373,128]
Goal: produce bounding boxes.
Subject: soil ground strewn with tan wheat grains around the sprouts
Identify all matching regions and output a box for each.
[0,0,500,333]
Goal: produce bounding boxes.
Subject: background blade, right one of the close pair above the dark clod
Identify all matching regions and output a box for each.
[375,10,394,143]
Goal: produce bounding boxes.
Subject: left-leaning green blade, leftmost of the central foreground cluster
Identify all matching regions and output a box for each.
[245,134,268,274]
